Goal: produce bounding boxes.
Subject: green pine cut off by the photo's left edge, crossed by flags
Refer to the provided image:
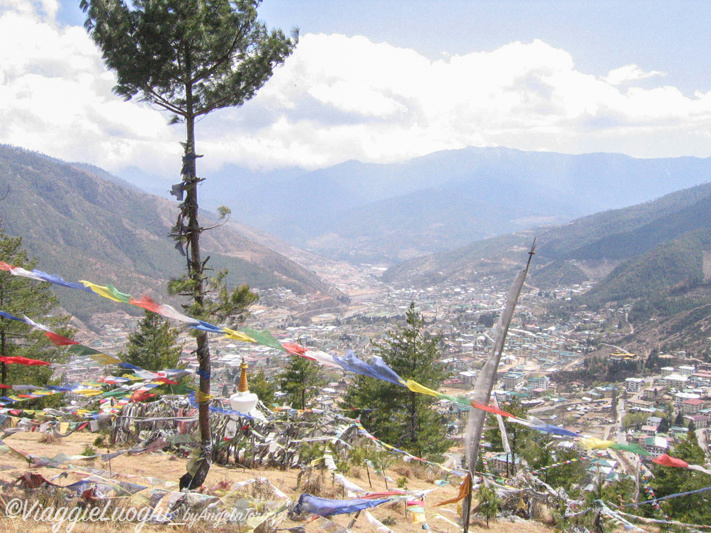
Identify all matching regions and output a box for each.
[0,228,71,386]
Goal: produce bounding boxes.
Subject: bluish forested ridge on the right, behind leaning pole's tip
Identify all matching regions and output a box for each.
[384,178,711,302]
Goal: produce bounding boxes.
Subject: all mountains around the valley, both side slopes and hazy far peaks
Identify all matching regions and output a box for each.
[6,141,711,352]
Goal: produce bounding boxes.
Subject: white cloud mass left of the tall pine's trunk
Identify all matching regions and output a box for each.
[0,4,180,175]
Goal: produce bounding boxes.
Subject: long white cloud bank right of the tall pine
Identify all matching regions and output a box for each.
[224,35,711,166]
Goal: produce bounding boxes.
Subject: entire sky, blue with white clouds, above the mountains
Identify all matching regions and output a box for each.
[0,0,711,185]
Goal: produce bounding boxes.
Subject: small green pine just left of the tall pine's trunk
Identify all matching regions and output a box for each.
[118,311,183,370]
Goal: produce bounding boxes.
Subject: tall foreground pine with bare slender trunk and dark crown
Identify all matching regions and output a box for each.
[79,0,297,489]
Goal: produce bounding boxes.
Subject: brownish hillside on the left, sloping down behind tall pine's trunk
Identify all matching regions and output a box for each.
[0,145,343,318]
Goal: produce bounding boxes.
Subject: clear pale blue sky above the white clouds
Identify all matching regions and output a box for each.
[58,0,711,92]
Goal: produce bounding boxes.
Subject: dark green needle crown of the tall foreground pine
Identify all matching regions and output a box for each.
[80,0,297,120]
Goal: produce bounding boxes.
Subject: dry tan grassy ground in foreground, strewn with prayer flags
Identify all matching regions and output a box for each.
[0,432,572,533]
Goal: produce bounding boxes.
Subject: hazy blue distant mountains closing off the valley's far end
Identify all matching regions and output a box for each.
[195,147,711,265]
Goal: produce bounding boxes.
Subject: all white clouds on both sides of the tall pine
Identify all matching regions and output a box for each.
[0,4,711,180]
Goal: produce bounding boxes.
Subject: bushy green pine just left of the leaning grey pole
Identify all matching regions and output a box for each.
[343,302,451,457]
